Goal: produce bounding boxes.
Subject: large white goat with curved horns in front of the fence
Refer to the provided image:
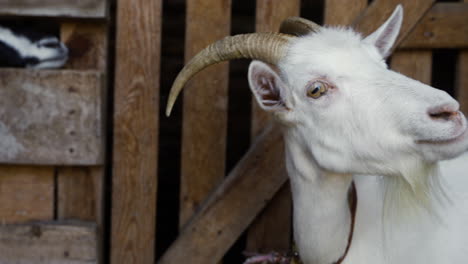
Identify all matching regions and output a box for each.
[167,6,468,264]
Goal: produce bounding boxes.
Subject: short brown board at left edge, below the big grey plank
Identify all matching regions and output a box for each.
[0,165,54,224]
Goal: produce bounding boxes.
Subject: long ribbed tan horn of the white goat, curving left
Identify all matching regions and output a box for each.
[166,33,292,116]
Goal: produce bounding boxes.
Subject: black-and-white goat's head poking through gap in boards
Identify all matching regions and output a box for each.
[0,25,68,69]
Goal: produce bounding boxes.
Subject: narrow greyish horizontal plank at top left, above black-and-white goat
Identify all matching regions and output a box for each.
[0,0,107,18]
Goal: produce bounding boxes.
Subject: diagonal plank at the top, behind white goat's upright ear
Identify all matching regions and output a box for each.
[353,0,435,45]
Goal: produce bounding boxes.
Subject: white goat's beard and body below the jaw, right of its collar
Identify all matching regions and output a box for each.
[350,152,468,264]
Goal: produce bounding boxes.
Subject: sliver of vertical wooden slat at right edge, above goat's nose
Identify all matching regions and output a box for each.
[455,0,468,112]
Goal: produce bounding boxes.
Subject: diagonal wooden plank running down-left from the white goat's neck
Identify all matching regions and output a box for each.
[159,126,287,264]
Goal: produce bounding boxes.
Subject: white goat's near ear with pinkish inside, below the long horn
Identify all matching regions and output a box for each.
[249,61,287,112]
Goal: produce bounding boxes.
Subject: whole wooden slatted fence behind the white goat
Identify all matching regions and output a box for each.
[0,0,468,264]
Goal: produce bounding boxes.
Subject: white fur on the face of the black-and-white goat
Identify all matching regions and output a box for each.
[0,26,68,69]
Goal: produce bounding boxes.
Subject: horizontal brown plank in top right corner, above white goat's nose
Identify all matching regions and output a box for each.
[400,3,468,48]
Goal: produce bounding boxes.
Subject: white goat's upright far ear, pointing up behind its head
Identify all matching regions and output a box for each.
[365,5,403,58]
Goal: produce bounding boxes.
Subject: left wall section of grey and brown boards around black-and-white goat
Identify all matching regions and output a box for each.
[0,0,109,263]
